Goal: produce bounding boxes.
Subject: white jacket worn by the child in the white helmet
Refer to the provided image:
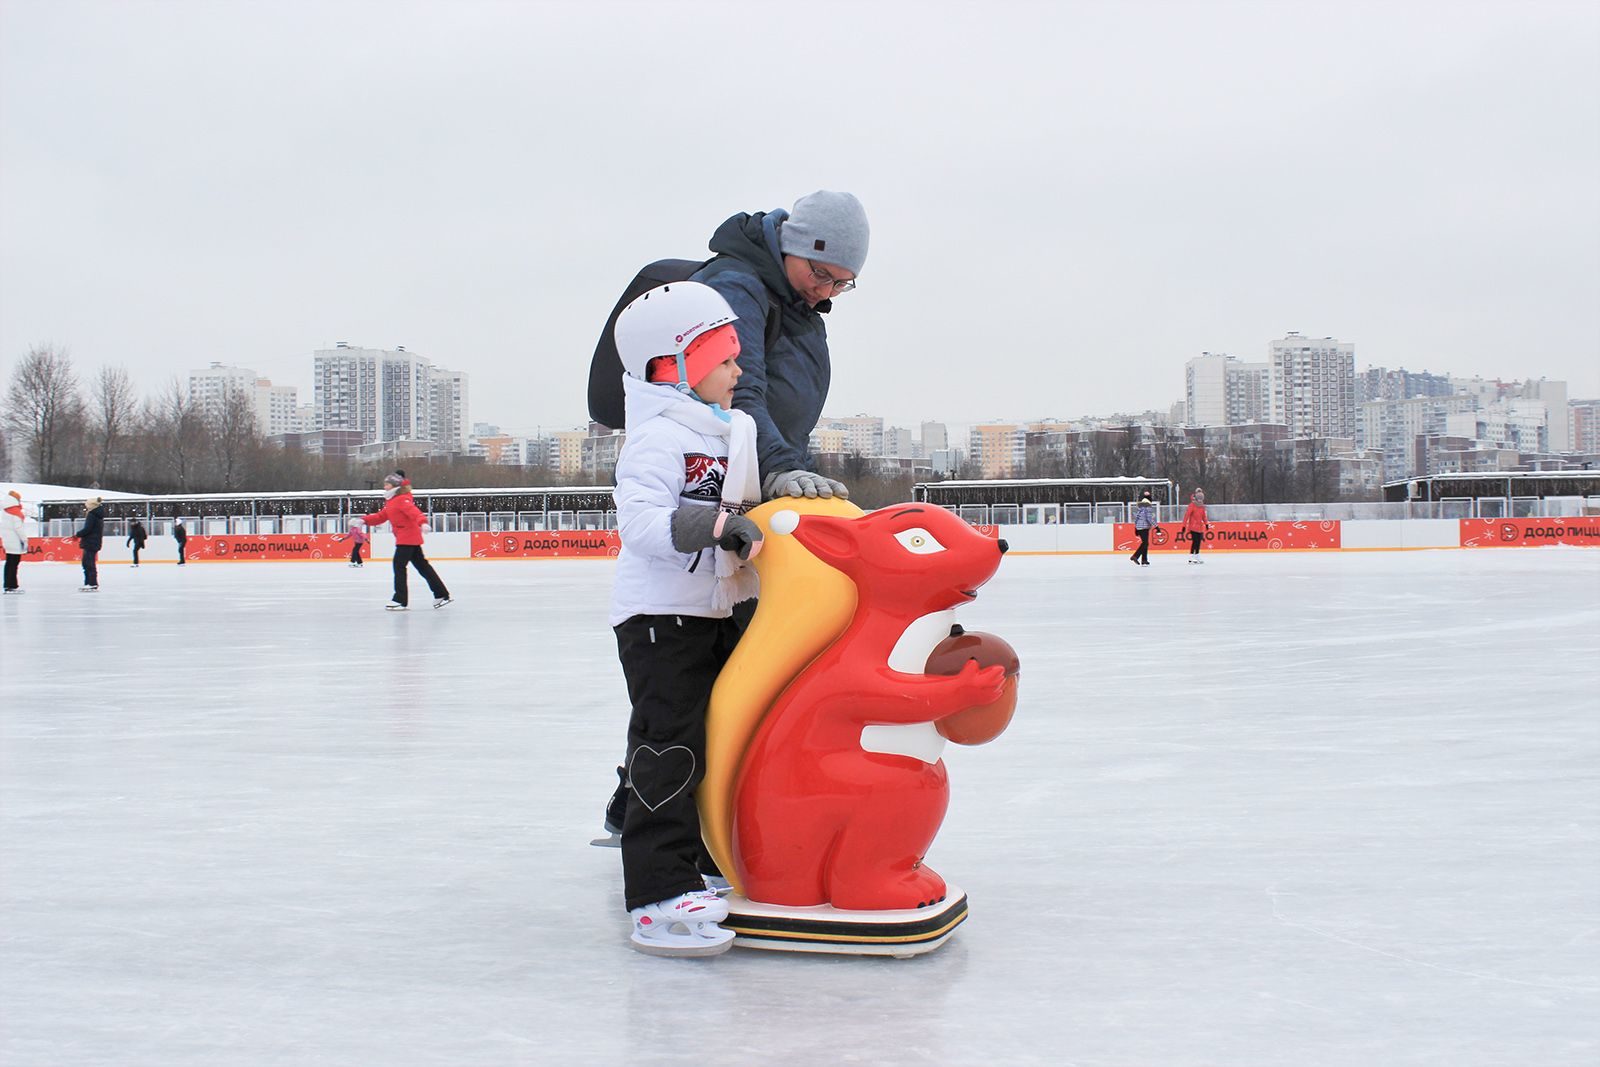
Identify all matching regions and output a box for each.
[610,376,731,625]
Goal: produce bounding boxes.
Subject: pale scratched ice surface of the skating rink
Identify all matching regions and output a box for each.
[0,549,1600,1067]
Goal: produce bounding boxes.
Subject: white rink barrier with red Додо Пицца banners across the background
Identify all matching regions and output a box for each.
[15,515,1600,565]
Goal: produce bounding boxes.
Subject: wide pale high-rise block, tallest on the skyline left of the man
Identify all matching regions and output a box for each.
[312,341,469,451]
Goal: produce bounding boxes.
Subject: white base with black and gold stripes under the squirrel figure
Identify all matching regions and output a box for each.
[722,885,968,958]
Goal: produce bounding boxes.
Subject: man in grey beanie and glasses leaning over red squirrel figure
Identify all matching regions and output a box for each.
[694,189,869,498]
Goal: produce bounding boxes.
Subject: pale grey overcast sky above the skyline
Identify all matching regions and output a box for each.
[0,0,1600,432]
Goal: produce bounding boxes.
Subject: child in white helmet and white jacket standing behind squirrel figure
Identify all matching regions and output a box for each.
[610,282,762,957]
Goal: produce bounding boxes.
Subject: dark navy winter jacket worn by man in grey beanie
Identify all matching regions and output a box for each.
[694,210,834,478]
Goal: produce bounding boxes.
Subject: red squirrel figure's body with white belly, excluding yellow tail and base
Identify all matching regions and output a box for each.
[733,504,1006,910]
